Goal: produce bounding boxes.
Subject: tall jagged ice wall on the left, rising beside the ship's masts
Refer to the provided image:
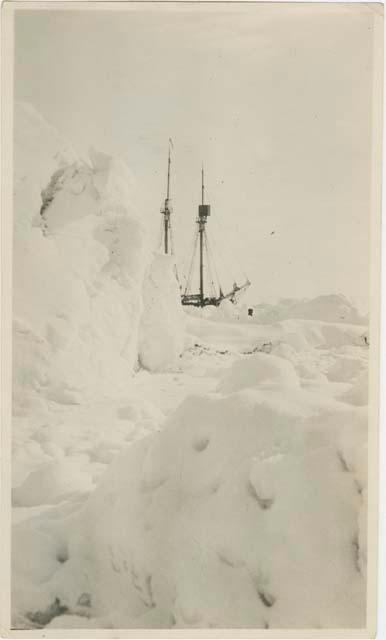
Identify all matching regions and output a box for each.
[14,104,182,413]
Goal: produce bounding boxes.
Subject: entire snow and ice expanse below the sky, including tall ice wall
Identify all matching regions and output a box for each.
[12,105,369,634]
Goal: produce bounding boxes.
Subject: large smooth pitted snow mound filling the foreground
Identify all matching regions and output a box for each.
[15,392,366,628]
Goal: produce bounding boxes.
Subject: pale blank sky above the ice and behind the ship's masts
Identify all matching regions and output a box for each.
[15,3,374,310]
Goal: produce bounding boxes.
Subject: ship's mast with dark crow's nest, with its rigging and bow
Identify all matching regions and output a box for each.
[181,168,251,307]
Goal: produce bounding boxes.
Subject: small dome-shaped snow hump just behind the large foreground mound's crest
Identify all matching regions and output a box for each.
[219,353,299,393]
